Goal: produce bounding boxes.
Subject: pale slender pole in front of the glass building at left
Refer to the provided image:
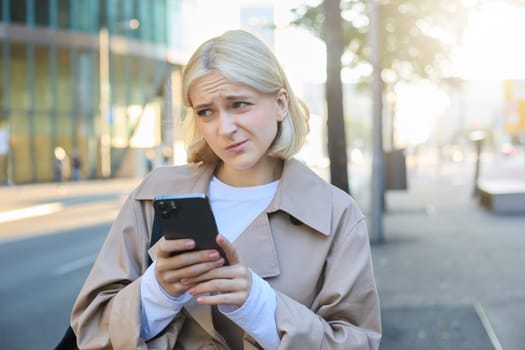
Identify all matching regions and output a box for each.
[99,26,111,177]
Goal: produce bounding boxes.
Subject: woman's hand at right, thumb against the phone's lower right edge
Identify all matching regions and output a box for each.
[181,235,252,307]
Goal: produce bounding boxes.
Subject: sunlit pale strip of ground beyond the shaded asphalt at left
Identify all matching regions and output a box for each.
[0,178,140,243]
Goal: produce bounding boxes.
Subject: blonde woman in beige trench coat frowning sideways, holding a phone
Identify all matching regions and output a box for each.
[72,30,381,350]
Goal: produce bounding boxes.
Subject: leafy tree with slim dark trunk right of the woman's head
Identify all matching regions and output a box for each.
[293,0,519,183]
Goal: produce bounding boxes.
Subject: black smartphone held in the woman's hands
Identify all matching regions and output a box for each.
[153,193,226,259]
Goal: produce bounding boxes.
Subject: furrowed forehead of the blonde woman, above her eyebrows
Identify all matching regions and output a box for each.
[188,71,258,105]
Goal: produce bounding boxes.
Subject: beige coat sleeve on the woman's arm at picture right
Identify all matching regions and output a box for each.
[276,217,381,350]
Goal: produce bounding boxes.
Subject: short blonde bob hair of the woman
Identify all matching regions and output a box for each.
[182,30,310,163]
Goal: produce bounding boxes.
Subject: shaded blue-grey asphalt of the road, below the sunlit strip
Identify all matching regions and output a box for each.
[0,224,109,350]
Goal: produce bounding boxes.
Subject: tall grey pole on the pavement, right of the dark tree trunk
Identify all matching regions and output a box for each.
[368,0,384,243]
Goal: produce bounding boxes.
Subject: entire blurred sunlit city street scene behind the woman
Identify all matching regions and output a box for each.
[0,0,525,349]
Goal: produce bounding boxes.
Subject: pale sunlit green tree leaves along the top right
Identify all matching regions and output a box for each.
[293,0,523,84]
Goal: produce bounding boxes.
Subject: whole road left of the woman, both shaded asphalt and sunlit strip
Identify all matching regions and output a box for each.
[0,179,138,350]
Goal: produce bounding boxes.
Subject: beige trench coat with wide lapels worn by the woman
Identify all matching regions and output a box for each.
[71,159,381,350]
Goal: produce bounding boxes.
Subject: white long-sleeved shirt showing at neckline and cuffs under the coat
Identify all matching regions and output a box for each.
[140,177,280,349]
